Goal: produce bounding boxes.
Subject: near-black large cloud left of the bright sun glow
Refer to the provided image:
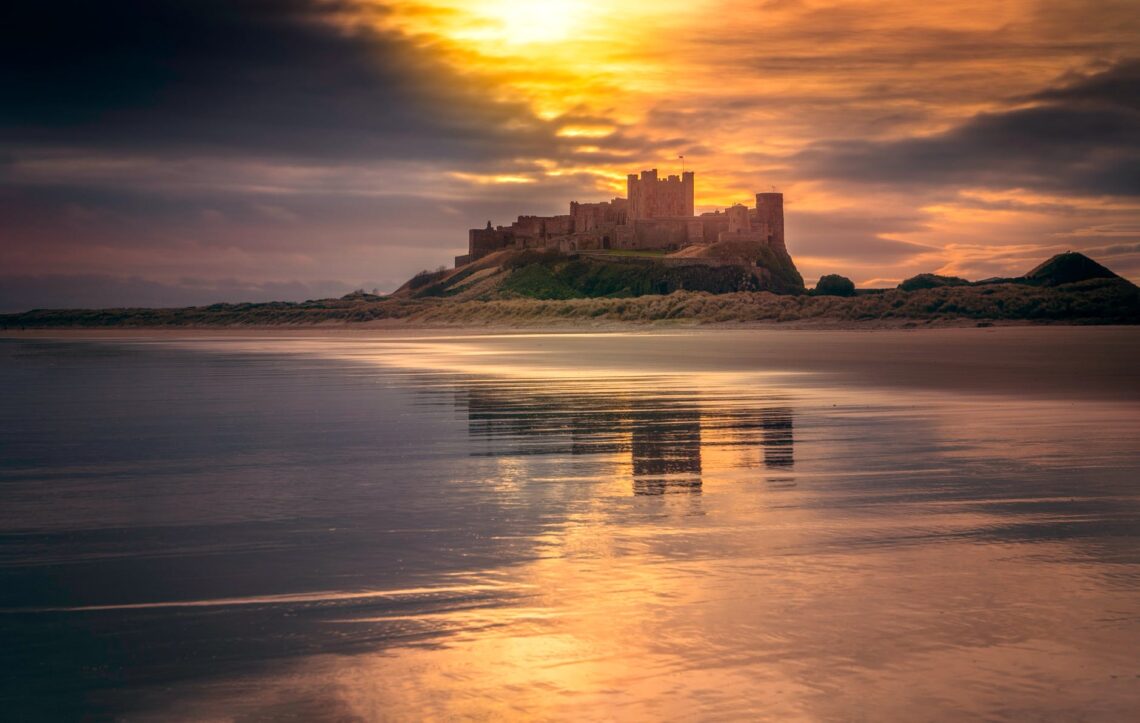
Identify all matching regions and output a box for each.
[0,0,557,162]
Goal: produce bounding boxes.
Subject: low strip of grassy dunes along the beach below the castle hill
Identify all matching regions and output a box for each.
[0,278,1140,333]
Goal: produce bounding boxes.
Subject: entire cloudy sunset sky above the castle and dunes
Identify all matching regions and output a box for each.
[0,0,1140,311]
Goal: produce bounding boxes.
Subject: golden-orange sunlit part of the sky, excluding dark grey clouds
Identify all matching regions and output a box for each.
[374,0,1140,283]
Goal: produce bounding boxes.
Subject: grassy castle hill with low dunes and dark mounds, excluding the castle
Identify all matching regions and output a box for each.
[0,251,1140,330]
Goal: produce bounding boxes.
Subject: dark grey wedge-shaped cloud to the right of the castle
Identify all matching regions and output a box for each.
[795,62,1140,196]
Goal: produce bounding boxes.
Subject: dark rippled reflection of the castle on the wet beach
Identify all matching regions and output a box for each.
[457,380,795,495]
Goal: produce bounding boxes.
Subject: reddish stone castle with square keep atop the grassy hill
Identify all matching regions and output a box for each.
[455,169,788,267]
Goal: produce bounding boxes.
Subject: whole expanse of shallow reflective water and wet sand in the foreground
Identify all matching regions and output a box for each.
[0,327,1140,721]
